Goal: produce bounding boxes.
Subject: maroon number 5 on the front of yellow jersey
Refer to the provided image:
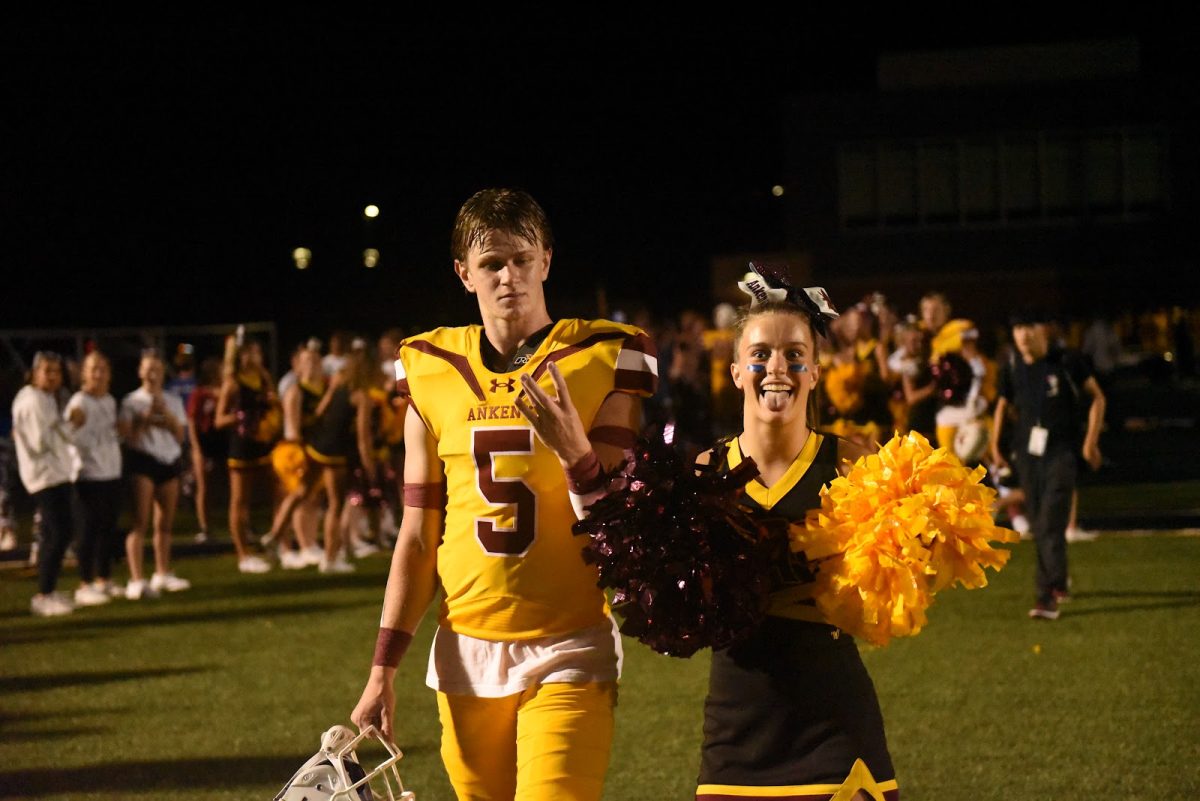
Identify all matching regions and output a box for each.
[470,428,538,556]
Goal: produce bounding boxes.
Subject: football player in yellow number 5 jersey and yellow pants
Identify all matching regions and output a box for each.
[352,189,658,801]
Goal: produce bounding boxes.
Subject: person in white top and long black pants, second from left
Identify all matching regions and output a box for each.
[65,350,121,607]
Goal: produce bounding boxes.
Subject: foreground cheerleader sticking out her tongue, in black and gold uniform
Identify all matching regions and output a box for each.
[696,276,899,801]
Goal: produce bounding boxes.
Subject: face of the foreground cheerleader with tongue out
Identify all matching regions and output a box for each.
[731,313,818,424]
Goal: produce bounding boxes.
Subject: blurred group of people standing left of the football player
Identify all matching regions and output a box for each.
[0,330,406,616]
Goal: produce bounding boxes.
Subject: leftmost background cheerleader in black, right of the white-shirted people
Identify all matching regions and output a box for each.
[216,337,281,573]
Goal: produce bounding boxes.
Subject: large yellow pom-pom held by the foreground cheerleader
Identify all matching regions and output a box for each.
[791,433,1018,645]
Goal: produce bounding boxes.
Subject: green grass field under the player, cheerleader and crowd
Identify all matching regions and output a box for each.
[0,532,1200,801]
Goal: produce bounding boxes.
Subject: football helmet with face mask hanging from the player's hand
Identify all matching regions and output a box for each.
[274,725,415,801]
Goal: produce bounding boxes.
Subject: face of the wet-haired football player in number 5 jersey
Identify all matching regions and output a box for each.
[454,230,551,321]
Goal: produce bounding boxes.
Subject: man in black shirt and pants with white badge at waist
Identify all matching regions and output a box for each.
[991,312,1105,620]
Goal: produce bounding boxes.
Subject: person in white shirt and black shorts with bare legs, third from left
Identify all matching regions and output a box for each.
[118,350,191,601]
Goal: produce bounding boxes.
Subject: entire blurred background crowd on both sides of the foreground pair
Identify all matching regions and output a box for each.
[0,297,1200,614]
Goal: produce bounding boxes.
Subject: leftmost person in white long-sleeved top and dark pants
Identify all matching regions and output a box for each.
[12,351,84,618]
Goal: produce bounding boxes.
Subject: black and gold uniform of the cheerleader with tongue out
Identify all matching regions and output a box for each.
[696,432,900,801]
